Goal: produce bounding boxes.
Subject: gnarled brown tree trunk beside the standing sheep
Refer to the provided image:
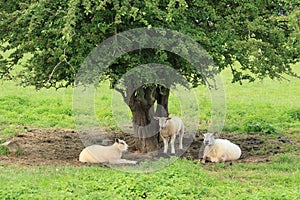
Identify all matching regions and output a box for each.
[123,86,170,153]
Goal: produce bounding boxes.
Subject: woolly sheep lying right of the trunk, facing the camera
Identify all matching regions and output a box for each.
[202,133,242,163]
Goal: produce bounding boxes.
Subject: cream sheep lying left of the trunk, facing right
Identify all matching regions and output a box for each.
[79,138,137,164]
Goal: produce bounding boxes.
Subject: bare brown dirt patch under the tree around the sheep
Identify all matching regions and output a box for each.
[0,128,299,166]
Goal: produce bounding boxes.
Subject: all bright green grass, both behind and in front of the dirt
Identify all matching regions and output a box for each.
[0,64,300,200]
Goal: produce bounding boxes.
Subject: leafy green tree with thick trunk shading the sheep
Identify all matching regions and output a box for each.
[0,0,300,151]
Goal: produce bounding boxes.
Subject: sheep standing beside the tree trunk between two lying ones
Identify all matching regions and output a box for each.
[154,117,184,154]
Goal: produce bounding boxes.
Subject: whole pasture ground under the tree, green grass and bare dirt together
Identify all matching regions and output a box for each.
[0,64,300,199]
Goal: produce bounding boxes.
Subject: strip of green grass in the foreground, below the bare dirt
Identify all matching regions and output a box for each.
[0,156,300,200]
